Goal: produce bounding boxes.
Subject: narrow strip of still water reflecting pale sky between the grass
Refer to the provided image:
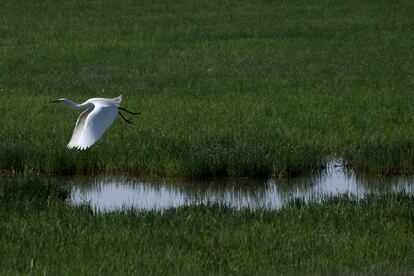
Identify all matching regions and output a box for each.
[70,161,414,212]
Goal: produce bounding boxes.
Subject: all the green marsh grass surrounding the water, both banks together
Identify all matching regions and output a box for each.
[0,0,414,275]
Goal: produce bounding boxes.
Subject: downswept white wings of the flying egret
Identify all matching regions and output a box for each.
[67,102,118,150]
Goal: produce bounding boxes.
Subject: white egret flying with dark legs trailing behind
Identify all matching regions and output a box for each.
[52,95,140,150]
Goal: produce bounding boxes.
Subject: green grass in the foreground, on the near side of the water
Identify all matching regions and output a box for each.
[0,178,414,275]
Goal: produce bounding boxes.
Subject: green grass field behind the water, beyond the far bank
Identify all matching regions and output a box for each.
[0,0,414,177]
